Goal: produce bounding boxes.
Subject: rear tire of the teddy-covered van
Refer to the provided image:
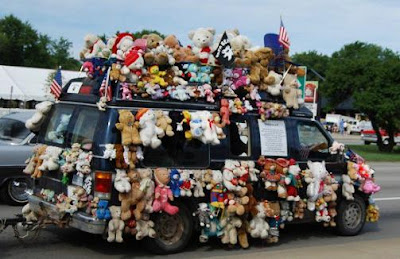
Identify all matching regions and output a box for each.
[145,205,193,254]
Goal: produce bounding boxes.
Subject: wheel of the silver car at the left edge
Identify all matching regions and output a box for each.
[0,177,32,206]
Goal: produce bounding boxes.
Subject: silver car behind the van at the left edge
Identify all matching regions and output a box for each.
[0,111,36,205]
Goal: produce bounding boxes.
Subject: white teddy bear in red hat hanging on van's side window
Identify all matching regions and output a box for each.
[136,108,164,149]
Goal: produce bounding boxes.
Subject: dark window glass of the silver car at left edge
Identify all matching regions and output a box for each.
[0,118,30,142]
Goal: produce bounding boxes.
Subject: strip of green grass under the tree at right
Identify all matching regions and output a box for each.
[347,144,400,162]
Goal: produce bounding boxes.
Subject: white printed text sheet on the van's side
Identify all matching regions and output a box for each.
[258,120,288,157]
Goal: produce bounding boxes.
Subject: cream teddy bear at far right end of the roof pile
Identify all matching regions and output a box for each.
[282,74,302,109]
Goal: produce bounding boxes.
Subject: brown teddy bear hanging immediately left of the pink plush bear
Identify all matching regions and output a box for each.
[119,170,146,220]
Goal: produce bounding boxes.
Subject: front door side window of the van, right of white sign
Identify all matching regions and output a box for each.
[297,121,329,161]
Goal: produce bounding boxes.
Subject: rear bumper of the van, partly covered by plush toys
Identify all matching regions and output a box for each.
[28,195,106,234]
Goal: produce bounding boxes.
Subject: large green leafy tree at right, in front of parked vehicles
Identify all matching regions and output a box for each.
[321,41,400,152]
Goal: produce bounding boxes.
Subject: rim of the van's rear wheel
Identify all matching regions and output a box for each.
[155,213,184,245]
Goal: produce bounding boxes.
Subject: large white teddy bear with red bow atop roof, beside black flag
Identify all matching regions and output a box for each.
[188,28,215,65]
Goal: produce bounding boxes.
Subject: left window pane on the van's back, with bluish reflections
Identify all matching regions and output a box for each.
[44,106,74,145]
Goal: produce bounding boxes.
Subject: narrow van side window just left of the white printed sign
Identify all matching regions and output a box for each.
[229,120,251,157]
